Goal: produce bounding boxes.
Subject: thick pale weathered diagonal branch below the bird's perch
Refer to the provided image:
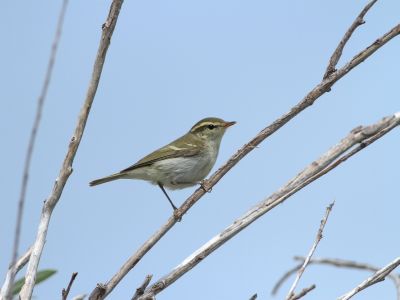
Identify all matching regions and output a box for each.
[139,112,400,300]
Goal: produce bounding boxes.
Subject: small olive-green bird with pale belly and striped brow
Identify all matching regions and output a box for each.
[89,117,236,211]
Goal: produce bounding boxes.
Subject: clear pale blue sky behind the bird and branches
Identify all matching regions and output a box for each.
[0,0,400,300]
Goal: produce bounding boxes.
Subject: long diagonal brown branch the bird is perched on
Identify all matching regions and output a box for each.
[89,17,400,300]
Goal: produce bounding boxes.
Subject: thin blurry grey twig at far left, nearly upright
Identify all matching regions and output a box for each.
[5,0,68,299]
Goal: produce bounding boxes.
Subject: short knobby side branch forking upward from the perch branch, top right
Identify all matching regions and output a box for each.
[323,0,378,79]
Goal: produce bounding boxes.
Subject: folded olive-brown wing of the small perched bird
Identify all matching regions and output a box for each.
[120,136,201,173]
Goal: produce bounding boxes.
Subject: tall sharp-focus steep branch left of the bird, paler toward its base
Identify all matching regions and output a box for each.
[20,0,123,300]
